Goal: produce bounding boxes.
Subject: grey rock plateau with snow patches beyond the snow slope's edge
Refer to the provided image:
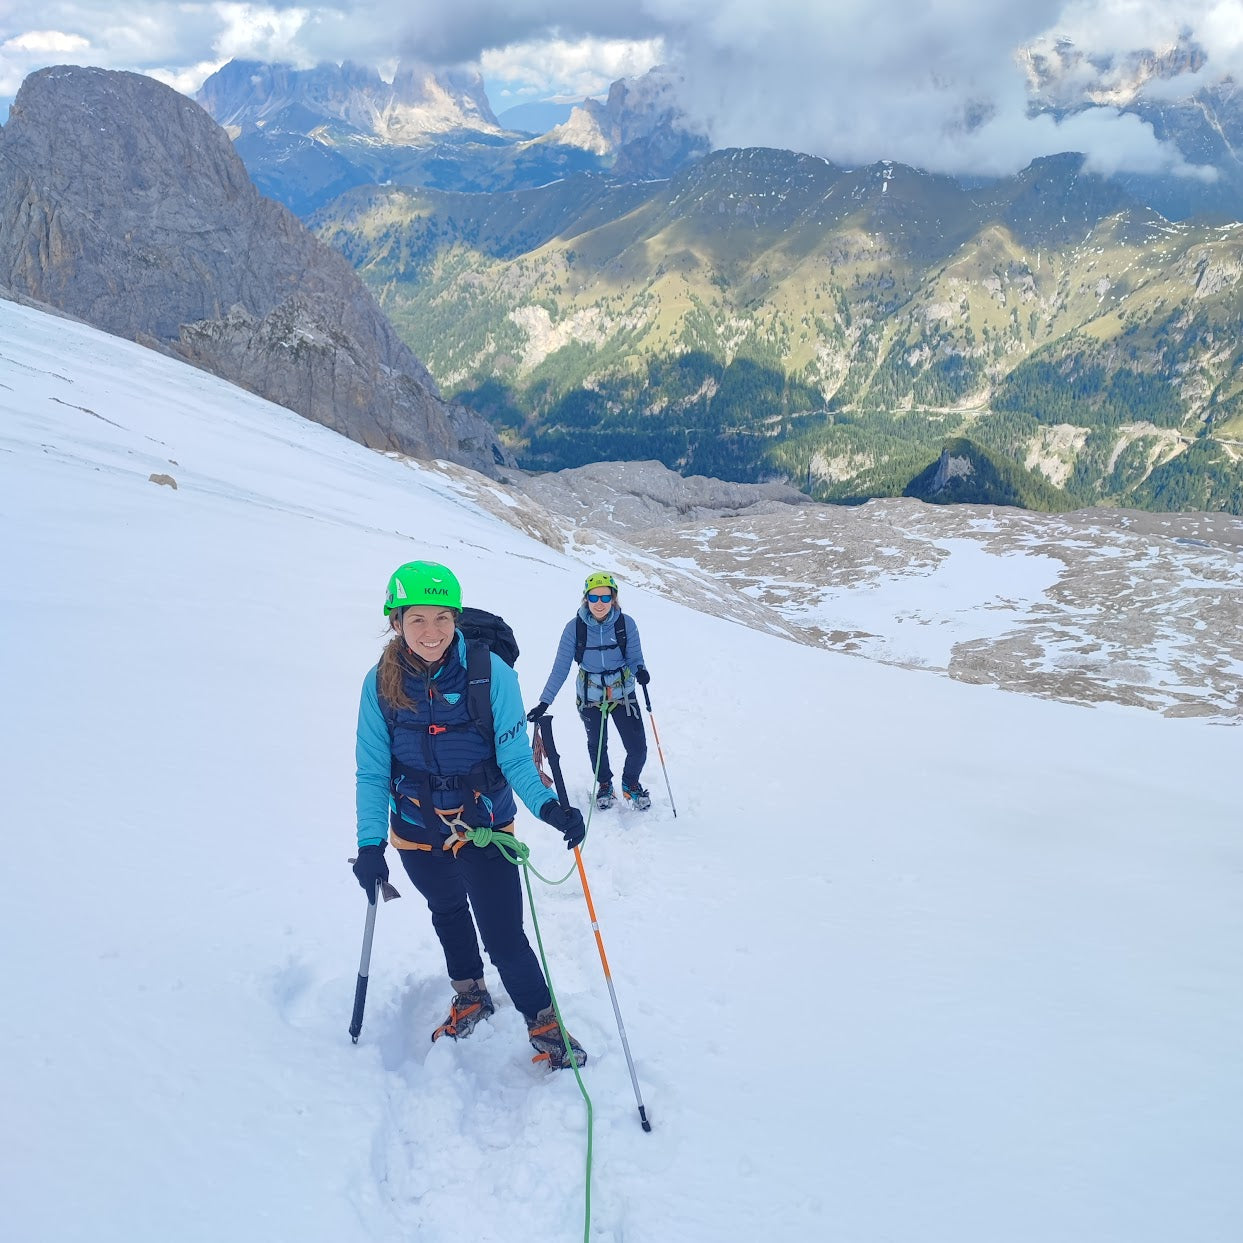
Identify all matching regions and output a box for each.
[440,462,1243,722]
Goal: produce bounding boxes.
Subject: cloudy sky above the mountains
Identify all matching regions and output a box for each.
[0,0,1243,173]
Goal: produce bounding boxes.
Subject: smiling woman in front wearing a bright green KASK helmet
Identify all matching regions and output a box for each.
[354,561,587,1069]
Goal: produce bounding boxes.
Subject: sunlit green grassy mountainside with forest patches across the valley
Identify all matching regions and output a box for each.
[313,149,1243,513]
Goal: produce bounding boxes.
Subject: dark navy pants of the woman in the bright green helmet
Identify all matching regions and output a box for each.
[398,842,552,1019]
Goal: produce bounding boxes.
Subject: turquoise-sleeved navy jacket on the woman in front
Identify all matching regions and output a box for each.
[354,631,557,846]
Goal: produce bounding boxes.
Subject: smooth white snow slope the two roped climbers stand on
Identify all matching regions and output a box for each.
[0,302,1243,1243]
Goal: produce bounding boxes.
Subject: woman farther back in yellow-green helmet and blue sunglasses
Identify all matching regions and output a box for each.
[527,571,651,812]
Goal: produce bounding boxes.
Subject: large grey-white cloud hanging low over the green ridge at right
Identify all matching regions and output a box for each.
[653,0,1228,174]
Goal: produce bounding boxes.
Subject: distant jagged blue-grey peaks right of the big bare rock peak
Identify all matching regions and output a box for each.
[195,61,707,216]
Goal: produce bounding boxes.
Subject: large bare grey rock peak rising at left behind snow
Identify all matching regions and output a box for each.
[0,66,512,474]
